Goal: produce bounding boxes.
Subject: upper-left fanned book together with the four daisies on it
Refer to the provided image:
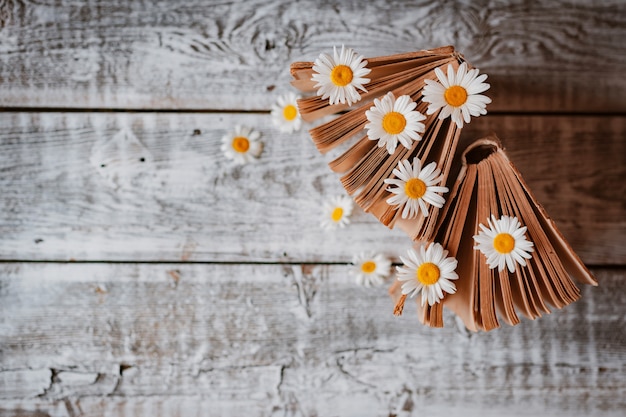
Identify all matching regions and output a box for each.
[291,46,491,239]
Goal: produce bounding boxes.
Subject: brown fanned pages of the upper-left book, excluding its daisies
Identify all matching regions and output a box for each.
[291,46,470,239]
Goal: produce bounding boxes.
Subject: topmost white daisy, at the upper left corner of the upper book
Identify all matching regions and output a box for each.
[311,45,371,106]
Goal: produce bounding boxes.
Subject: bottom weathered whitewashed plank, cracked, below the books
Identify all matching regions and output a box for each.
[0,263,626,417]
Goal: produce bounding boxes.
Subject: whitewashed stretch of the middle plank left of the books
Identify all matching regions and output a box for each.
[0,113,410,262]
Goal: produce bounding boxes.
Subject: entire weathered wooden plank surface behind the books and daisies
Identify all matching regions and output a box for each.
[0,0,626,417]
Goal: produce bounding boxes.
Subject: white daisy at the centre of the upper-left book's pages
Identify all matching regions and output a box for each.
[365,92,426,155]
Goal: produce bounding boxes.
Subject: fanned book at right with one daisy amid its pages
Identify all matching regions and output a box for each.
[390,136,597,331]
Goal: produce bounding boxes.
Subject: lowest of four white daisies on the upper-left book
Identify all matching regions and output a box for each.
[384,158,448,219]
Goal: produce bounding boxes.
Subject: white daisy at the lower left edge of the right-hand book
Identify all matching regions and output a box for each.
[396,243,459,306]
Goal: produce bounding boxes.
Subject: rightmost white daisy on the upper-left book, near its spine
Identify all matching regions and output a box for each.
[423,62,491,129]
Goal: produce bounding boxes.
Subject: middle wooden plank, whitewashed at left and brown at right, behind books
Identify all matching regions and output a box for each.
[0,113,626,264]
